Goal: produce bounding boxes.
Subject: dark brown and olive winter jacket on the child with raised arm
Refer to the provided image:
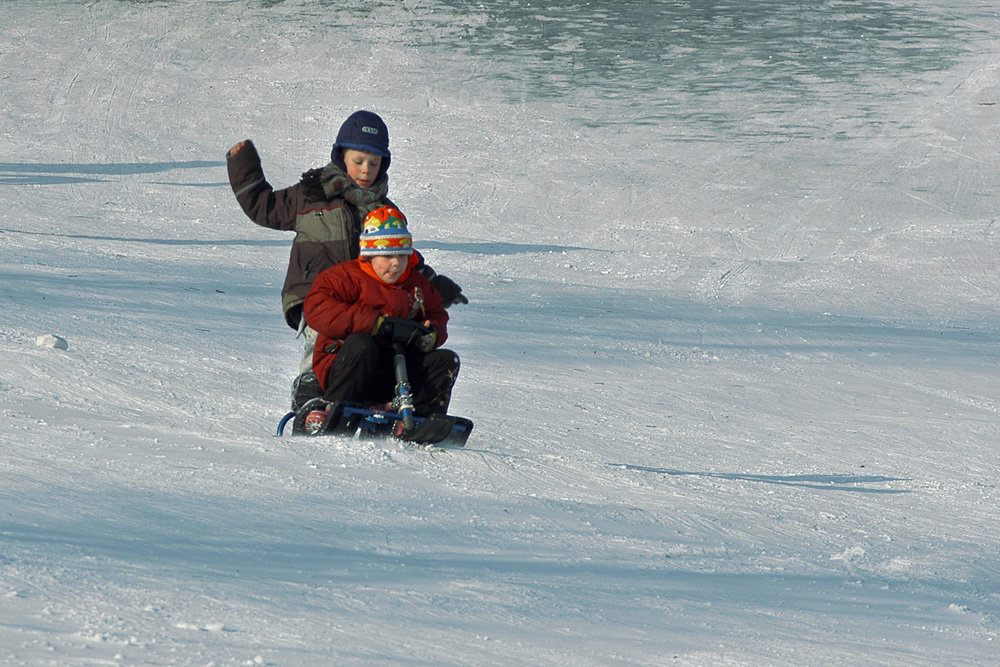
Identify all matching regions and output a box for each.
[226,141,394,329]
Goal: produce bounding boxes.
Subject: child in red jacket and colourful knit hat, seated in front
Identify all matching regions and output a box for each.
[304,206,459,416]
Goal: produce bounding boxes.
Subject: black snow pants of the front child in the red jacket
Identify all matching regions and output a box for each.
[323,333,459,416]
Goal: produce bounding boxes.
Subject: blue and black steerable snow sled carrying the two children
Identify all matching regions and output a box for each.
[277,317,472,447]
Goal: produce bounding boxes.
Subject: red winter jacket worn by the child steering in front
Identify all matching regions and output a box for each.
[304,253,448,390]
